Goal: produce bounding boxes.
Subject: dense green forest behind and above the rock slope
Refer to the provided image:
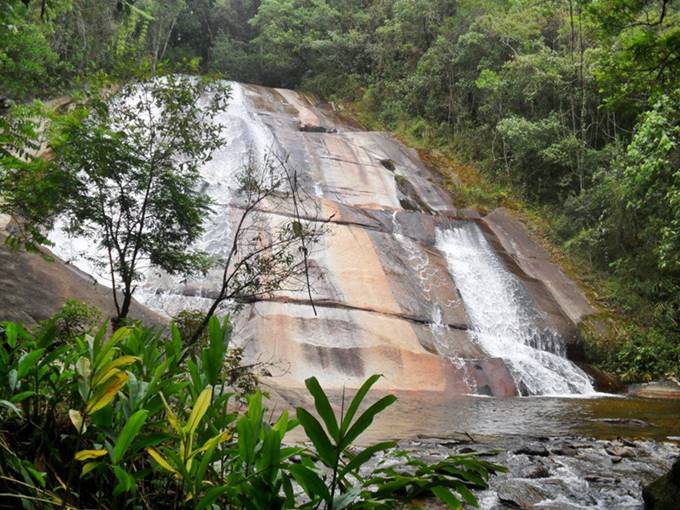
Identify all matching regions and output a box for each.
[0,0,680,374]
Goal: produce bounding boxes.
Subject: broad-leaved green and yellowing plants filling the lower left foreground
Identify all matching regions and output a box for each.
[0,306,503,509]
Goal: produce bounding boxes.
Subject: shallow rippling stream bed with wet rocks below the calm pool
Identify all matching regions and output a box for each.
[388,436,680,510]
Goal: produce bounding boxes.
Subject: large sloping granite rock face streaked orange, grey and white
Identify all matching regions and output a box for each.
[38,84,589,396]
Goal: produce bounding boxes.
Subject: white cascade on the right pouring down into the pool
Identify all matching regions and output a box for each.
[437,221,594,395]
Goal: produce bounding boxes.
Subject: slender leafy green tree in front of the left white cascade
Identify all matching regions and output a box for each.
[51,75,228,322]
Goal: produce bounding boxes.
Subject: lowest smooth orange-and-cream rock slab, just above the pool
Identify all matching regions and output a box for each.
[236,302,516,396]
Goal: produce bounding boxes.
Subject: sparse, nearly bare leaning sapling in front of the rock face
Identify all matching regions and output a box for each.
[189,154,332,344]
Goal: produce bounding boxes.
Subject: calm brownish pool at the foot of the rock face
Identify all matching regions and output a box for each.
[279,389,680,442]
